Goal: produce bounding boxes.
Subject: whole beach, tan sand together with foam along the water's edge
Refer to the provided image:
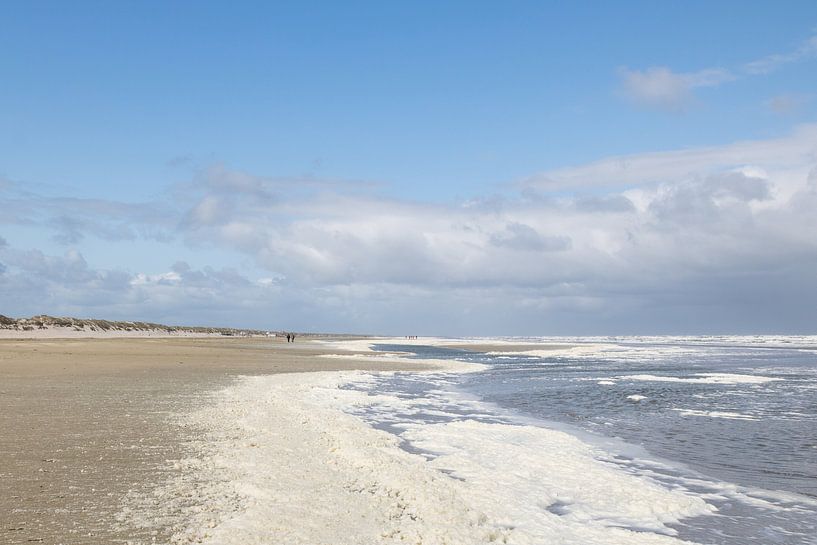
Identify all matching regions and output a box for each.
[7,336,796,545]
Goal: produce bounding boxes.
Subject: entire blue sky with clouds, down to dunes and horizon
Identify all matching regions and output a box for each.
[0,0,817,336]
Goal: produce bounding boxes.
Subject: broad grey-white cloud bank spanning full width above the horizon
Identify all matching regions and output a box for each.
[0,125,817,335]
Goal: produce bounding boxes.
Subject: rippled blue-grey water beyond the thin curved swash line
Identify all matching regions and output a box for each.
[464,345,817,497]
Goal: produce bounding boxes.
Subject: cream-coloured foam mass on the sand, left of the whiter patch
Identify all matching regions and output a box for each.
[122,373,505,545]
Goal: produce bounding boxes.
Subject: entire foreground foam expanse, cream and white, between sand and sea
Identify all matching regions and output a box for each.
[126,372,713,545]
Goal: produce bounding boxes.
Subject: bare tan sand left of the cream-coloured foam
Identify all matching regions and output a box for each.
[0,337,428,545]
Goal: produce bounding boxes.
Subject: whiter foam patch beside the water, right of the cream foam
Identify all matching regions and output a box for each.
[403,420,714,544]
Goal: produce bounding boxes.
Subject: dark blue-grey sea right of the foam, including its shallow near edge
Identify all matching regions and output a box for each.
[368,339,817,545]
